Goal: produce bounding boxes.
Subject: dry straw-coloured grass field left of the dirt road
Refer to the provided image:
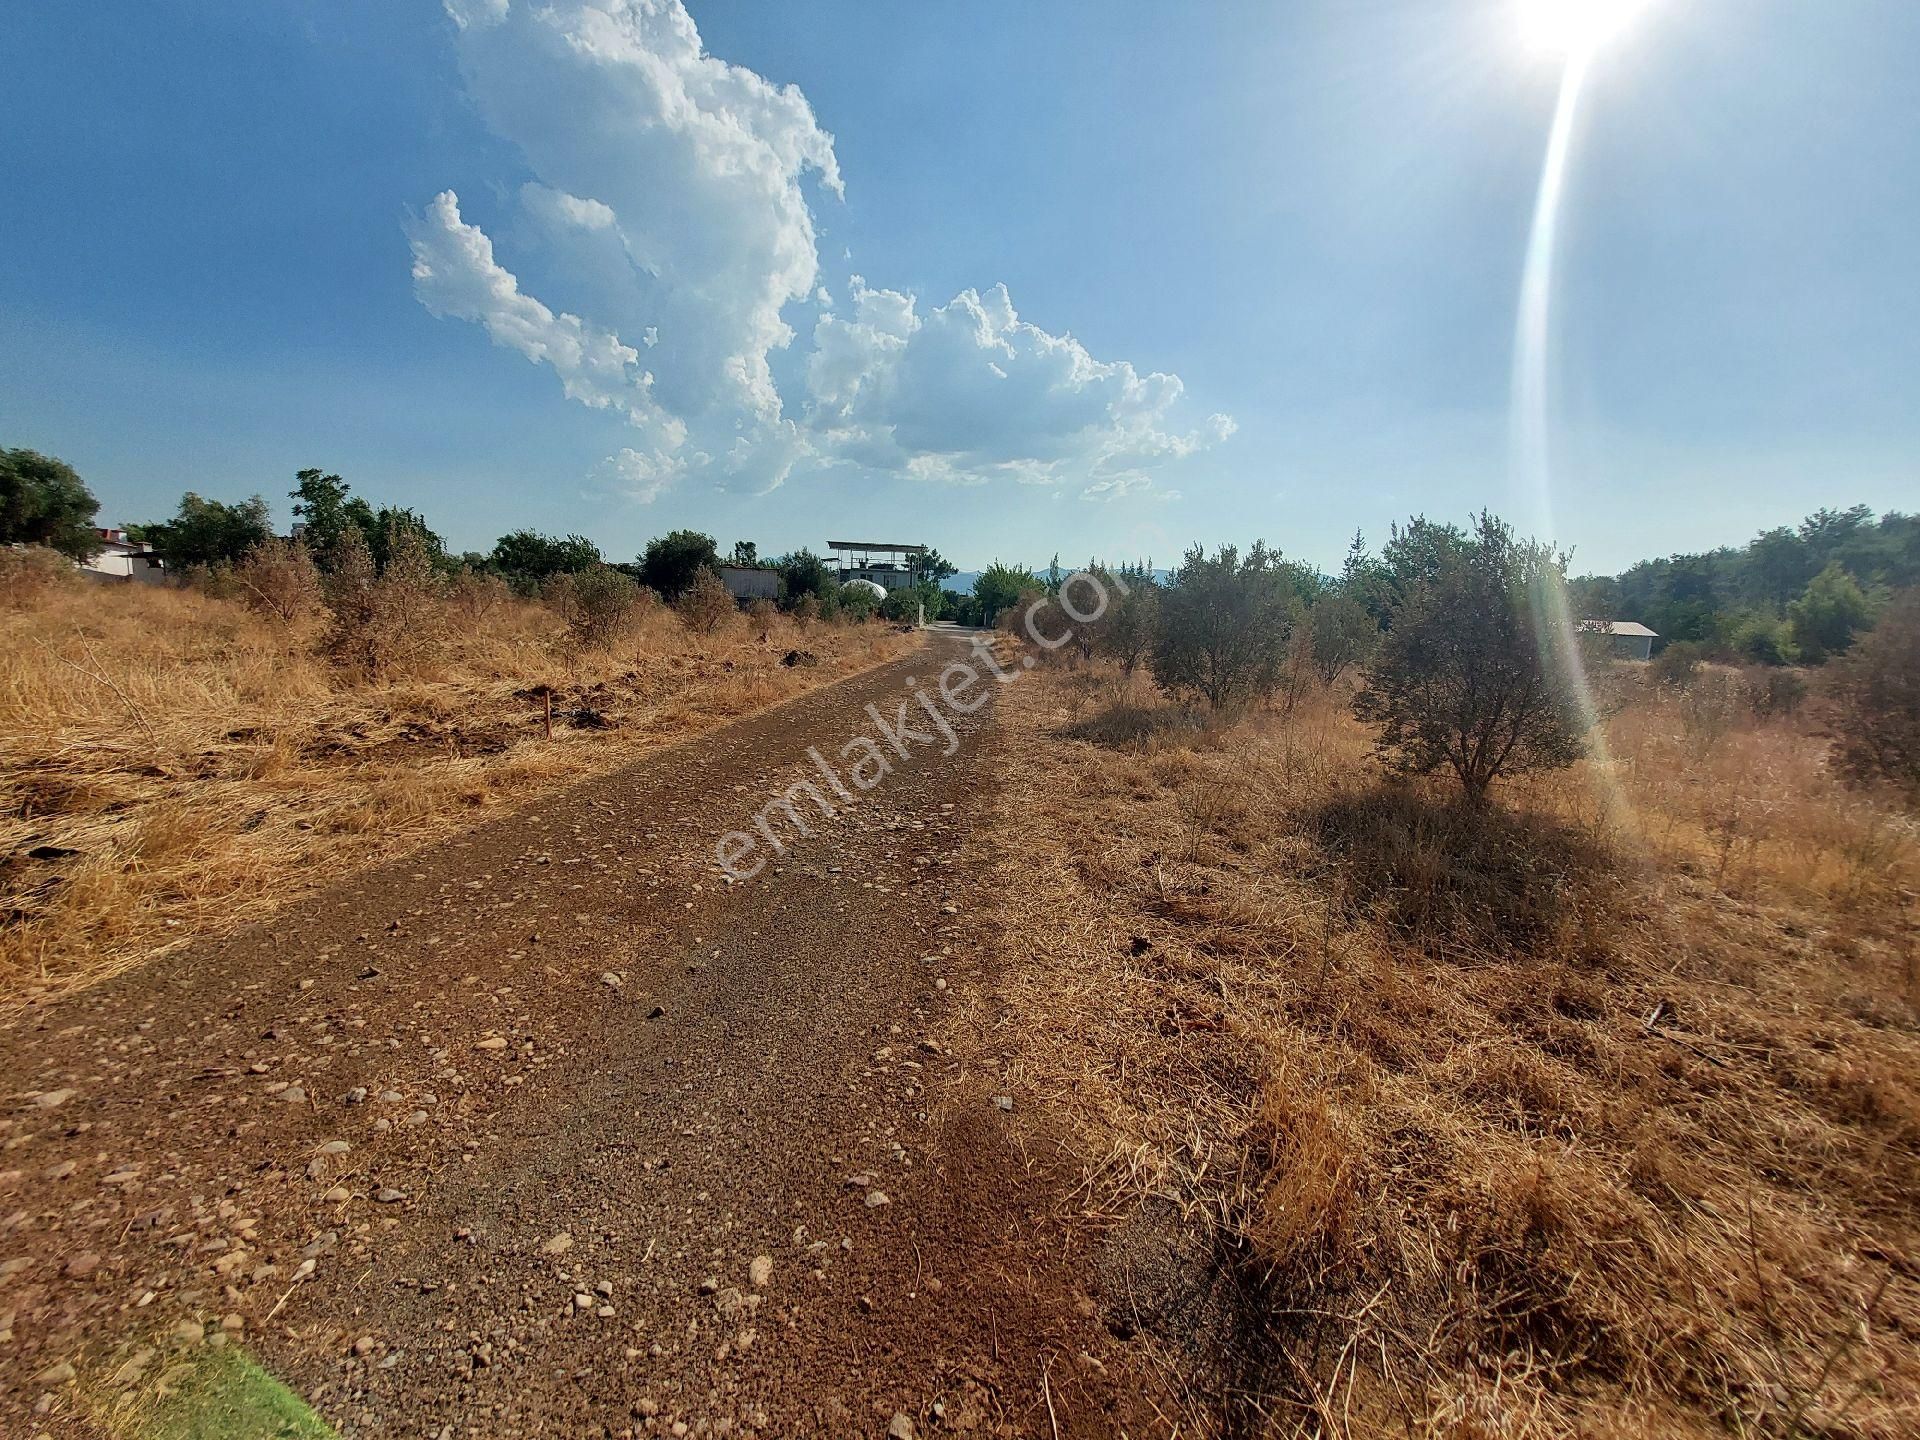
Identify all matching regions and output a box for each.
[0,584,916,1004]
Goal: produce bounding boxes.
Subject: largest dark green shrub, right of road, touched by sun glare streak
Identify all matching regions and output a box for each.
[1354,515,1588,801]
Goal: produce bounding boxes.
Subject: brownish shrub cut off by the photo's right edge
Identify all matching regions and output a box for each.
[1828,589,1920,801]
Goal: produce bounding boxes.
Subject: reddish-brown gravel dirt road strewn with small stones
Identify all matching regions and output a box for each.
[0,636,1162,1440]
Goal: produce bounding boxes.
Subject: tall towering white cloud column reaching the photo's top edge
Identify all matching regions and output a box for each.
[457,0,841,428]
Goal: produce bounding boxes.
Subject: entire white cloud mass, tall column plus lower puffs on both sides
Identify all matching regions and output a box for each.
[409,0,1233,499]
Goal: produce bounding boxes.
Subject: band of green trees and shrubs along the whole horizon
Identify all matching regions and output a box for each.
[0,449,1920,801]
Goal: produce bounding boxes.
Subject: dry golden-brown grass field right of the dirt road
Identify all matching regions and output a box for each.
[996,672,1920,1436]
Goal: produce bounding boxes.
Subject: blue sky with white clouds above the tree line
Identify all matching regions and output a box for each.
[0,0,1920,570]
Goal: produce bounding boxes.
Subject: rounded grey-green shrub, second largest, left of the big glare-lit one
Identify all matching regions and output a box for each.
[1154,540,1300,710]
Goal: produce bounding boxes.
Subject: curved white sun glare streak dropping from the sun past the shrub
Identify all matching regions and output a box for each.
[1511,54,1632,826]
